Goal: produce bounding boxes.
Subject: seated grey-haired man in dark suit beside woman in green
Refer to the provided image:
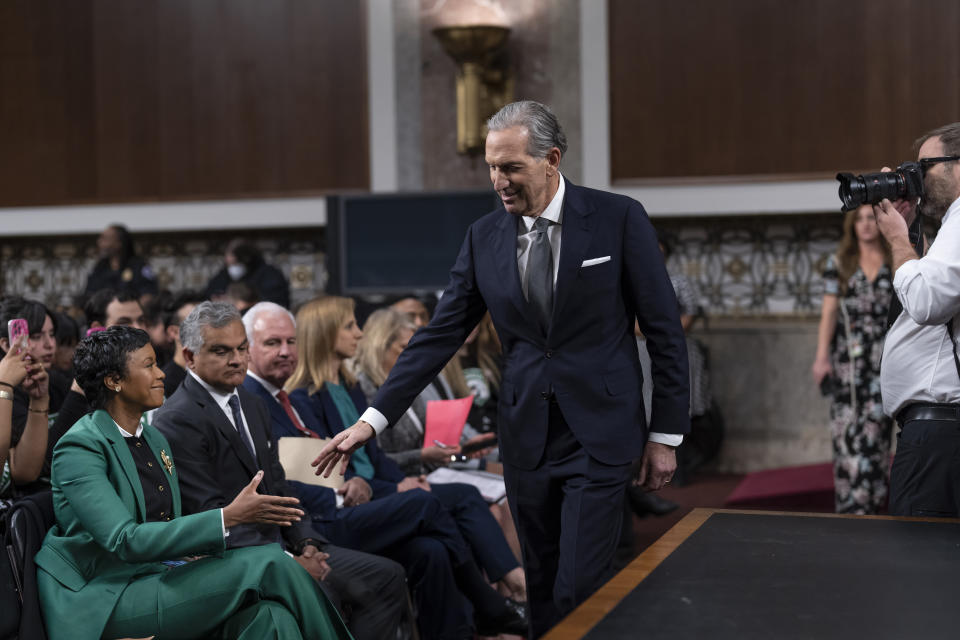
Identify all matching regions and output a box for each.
[154,302,407,640]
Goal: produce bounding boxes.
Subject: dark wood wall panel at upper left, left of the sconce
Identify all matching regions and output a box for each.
[0,0,369,206]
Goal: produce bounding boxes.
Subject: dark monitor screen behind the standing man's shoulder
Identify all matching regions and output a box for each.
[327,190,499,295]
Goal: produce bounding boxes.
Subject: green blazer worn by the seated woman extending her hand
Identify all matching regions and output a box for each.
[36,410,225,640]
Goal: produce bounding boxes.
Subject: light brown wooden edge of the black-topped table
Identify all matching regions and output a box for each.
[542,507,960,640]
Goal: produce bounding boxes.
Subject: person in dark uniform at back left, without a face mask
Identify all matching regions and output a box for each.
[83,224,157,302]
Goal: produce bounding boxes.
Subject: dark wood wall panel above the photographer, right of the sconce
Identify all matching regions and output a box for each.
[609,0,960,183]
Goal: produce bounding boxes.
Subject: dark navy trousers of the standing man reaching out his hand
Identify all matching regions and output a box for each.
[503,402,630,638]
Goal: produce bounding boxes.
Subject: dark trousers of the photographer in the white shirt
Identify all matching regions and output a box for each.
[890,420,960,518]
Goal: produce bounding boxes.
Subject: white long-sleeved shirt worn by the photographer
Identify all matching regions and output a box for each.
[880,199,960,416]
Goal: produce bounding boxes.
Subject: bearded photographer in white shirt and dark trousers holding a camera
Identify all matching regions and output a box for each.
[874,122,960,518]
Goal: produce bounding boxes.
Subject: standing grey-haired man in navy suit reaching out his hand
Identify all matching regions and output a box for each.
[315,101,690,637]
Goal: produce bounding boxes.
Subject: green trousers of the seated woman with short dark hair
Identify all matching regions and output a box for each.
[103,544,350,640]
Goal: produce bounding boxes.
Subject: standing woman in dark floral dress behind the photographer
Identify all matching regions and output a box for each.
[813,205,893,514]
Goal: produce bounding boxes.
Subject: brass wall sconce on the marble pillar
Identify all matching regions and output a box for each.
[433,25,513,154]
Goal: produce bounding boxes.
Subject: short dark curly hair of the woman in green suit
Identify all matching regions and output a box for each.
[73,326,150,409]
